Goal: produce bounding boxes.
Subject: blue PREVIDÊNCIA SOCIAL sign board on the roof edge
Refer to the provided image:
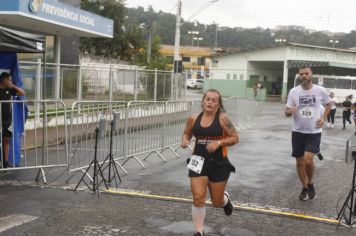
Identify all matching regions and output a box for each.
[0,0,114,38]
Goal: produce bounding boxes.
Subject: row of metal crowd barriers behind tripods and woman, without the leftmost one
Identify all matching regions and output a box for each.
[69,97,259,173]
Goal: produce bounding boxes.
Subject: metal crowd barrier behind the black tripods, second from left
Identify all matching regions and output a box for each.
[69,101,127,177]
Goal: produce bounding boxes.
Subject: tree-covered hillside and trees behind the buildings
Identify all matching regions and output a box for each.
[81,0,356,64]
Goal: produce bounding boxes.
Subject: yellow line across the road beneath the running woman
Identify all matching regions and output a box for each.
[104,189,339,224]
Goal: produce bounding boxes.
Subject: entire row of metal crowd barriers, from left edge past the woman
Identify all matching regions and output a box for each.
[0,97,259,182]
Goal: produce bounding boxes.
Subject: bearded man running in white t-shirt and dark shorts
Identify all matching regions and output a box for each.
[285,67,331,201]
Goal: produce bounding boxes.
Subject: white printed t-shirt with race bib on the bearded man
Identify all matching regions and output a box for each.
[287,84,330,134]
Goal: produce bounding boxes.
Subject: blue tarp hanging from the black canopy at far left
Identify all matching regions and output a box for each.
[0,52,27,166]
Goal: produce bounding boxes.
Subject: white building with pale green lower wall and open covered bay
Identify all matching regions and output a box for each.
[209,43,356,100]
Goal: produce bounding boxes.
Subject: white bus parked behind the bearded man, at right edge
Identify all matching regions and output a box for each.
[294,74,356,103]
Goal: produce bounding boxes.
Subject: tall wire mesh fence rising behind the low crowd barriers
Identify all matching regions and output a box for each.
[20,60,186,104]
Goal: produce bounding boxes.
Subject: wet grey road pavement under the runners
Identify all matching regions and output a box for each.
[0,103,356,236]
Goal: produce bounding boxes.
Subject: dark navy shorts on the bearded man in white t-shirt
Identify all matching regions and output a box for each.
[292,131,321,157]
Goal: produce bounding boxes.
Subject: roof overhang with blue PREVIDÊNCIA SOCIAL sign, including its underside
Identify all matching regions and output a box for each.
[0,0,114,38]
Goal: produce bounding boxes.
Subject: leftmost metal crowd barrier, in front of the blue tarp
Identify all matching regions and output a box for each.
[0,100,68,183]
